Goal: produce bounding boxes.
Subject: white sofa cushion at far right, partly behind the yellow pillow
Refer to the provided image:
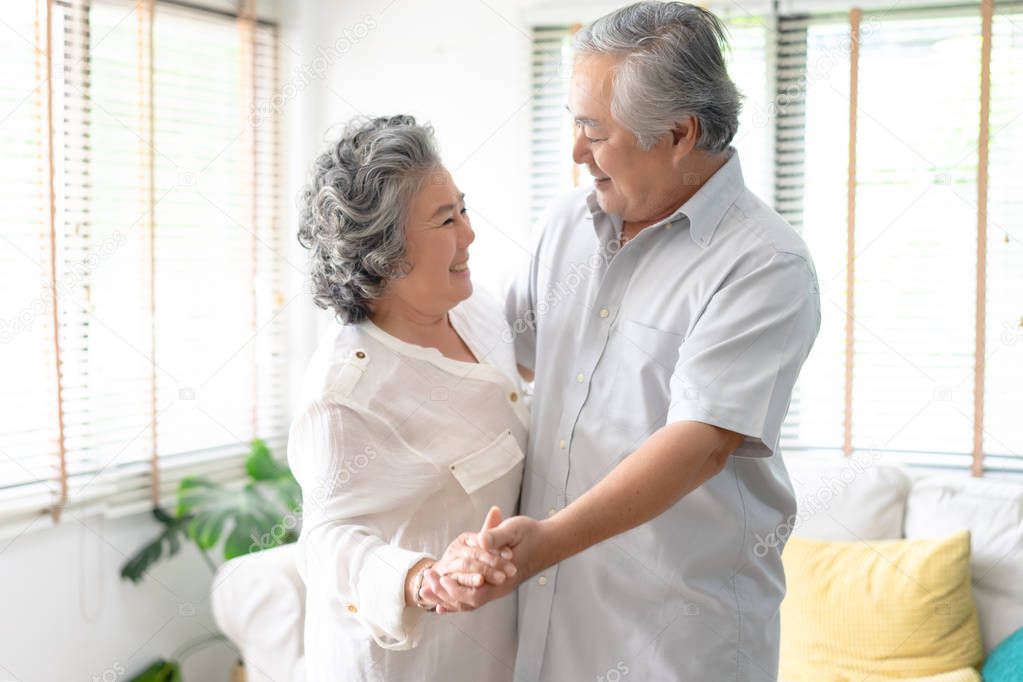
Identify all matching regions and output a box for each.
[905,475,1023,651]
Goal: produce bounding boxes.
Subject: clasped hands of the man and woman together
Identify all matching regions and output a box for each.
[409,507,543,613]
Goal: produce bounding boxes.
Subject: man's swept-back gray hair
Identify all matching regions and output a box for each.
[575,1,742,153]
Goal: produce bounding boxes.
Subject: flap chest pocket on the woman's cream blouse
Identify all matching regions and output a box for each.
[448,430,525,517]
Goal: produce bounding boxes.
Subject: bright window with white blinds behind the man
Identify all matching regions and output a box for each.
[533,0,1023,474]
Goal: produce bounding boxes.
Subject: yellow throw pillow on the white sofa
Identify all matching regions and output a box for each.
[780,532,983,682]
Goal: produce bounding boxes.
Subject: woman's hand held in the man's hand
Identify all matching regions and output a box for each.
[405,507,519,613]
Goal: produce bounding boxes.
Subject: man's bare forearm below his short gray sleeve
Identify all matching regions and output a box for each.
[533,421,743,571]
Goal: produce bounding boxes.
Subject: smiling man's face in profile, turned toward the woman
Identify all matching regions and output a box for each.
[569,55,687,222]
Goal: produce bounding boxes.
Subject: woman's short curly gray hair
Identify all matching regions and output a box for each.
[299,116,441,323]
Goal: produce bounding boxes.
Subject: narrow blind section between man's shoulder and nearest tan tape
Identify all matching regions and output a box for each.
[774,16,849,449]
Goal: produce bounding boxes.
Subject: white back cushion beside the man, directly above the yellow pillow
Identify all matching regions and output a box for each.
[785,452,911,542]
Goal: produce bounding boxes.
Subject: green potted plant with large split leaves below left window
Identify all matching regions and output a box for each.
[121,439,302,682]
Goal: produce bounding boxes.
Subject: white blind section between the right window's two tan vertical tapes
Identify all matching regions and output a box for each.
[852,9,980,455]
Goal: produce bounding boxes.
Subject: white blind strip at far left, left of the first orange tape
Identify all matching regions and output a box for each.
[0,1,60,527]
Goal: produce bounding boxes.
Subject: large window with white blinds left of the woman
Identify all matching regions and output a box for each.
[0,0,286,531]
